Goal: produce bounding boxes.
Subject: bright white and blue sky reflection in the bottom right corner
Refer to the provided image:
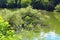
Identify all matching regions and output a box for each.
[40,32,60,40]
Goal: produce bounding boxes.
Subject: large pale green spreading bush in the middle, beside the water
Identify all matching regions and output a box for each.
[0,6,48,31]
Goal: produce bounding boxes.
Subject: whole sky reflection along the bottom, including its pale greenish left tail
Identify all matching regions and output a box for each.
[22,31,60,40]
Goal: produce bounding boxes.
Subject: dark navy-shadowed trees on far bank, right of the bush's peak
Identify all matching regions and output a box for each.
[31,0,60,11]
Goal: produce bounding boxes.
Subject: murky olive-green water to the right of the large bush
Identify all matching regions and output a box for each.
[45,12,60,34]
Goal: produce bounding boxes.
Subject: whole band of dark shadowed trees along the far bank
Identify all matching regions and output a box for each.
[0,0,60,11]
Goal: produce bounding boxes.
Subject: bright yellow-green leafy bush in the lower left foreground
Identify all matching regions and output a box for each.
[0,16,22,40]
